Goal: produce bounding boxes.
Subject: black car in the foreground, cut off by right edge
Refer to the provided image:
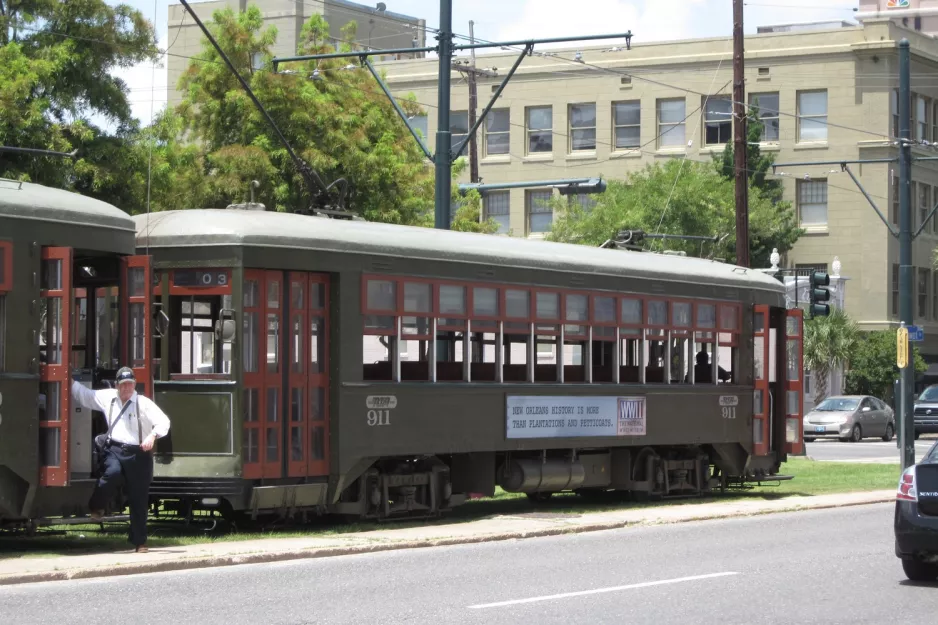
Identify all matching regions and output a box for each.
[895,443,938,581]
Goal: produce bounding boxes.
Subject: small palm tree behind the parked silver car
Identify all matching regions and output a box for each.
[804,308,860,404]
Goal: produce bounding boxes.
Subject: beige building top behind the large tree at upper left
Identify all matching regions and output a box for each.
[167,0,426,106]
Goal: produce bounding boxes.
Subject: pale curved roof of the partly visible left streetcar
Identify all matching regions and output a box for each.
[0,178,134,232]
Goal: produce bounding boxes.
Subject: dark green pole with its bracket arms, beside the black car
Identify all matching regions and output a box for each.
[772,39,938,469]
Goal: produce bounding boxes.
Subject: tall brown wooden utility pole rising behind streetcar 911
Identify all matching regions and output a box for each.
[733,0,749,267]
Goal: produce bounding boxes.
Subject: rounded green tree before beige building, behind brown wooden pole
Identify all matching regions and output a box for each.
[548,159,800,267]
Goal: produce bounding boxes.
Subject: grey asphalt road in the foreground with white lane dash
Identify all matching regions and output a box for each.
[0,504,938,625]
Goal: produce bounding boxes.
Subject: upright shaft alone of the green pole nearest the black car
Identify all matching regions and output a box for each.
[899,39,915,469]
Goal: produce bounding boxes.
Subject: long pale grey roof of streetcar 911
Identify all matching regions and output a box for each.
[133,209,785,292]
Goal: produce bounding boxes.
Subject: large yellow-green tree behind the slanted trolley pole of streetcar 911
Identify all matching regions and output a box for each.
[177,5,433,224]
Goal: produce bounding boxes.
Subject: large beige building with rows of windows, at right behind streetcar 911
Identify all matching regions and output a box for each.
[383,17,938,360]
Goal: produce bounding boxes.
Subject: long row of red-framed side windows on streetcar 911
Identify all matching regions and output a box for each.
[362,276,740,384]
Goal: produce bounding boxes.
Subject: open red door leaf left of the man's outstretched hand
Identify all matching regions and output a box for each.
[39,247,72,486]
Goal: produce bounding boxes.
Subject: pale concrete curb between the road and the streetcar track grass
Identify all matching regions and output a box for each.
[0,495,894,586]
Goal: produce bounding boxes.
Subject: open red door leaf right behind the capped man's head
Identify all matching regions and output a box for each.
[120,256,153,398]
